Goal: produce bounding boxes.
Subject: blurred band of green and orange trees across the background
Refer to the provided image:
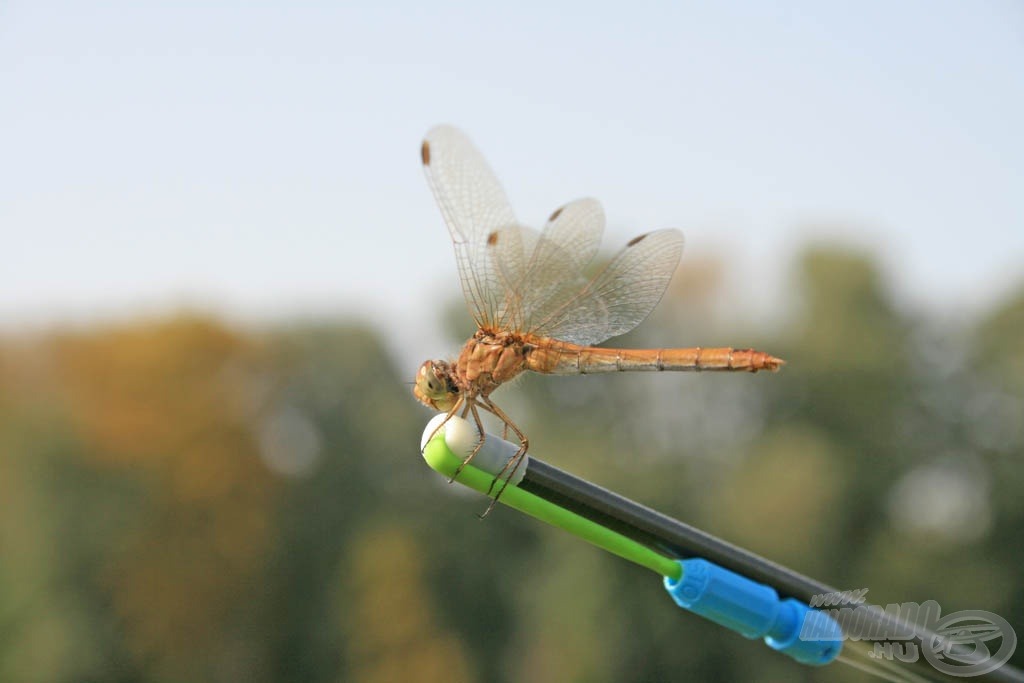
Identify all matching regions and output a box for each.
[0,248,1024,683]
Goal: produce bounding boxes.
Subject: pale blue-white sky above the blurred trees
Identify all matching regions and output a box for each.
[0,0,1024,358]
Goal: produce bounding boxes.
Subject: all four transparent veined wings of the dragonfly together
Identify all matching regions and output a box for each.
[422,126,683,344]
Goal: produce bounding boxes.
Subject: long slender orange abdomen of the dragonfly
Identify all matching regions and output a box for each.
[526,344,784,375]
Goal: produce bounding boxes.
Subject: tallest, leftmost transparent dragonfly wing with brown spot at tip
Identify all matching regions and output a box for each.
[422,126,534,328]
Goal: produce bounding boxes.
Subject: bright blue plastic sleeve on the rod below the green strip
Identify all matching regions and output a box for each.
[665,558,843,667]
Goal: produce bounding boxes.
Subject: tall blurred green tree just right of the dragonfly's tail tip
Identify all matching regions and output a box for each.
[751,248,914,588]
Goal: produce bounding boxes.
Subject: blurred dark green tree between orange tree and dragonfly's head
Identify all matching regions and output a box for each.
[260,325,429,682]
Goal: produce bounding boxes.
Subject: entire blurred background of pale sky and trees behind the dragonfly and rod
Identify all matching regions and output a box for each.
[0,0,1024,682]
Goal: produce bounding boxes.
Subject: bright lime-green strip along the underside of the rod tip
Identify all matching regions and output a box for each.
[423,430,682,581]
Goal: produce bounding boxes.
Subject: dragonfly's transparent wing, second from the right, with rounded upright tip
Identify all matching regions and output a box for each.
[508,199,604,332]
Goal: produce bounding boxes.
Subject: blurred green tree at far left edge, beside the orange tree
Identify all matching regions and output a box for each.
[0,340,134,683]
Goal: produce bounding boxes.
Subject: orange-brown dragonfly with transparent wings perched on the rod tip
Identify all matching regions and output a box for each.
[413,125,784,501]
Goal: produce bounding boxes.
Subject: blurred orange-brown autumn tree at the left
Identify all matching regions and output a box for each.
[53,317,275,680]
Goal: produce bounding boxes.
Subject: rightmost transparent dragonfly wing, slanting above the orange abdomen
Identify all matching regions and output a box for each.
[531,230,683,345]
